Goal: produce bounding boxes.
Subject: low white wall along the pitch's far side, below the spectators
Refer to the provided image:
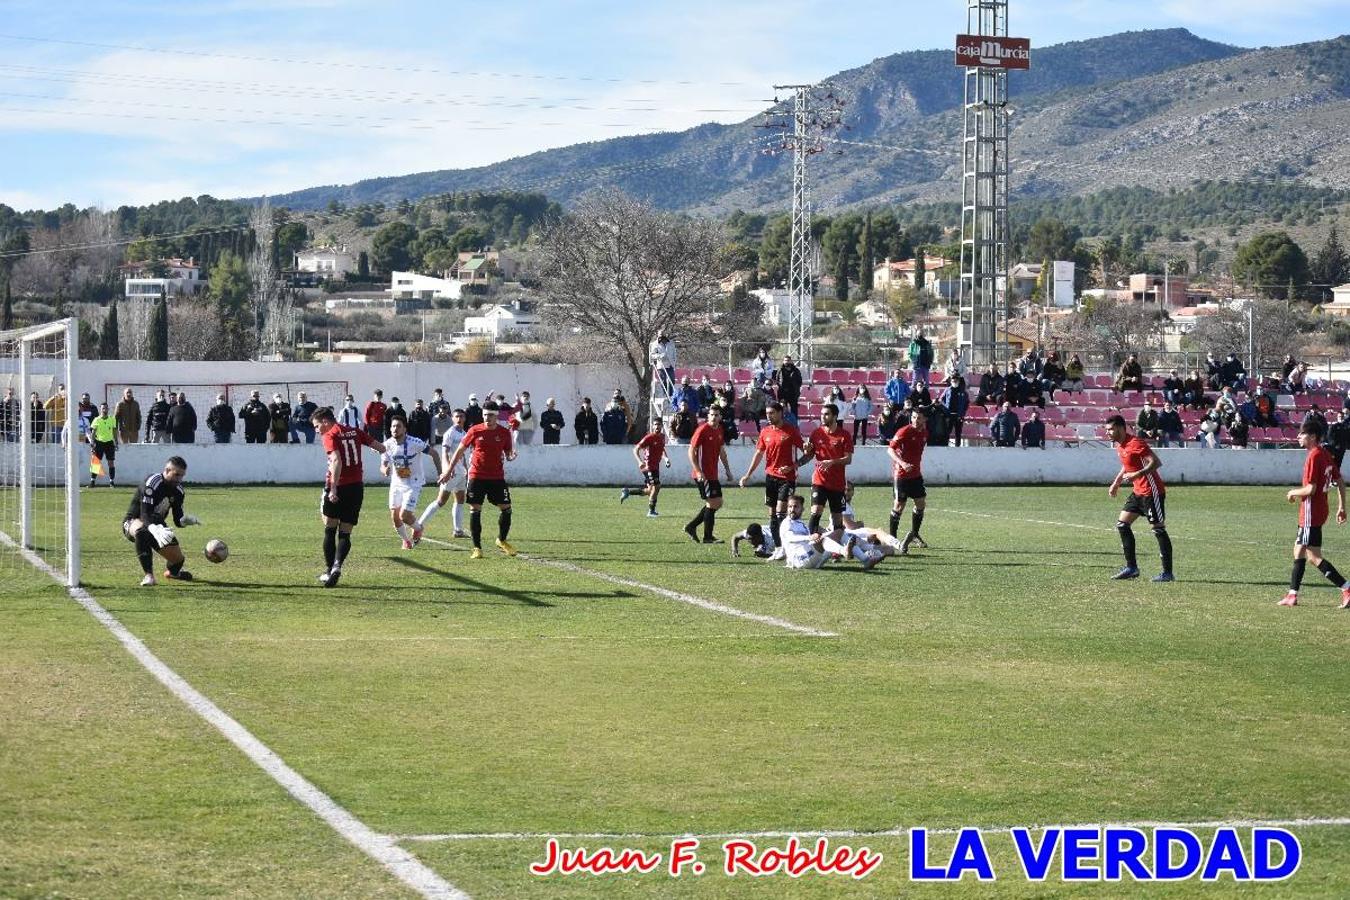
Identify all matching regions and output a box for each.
[99,444,1304,490]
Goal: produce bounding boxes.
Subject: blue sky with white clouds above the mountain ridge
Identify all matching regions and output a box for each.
[0,0,1350,209]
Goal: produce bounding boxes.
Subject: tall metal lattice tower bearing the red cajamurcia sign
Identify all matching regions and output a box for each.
[956,0,1031,368]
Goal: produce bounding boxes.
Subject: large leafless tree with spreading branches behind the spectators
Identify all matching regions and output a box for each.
[540,192,726,417]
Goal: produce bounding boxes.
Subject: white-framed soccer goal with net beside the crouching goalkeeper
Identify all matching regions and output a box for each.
[0,318,79,587]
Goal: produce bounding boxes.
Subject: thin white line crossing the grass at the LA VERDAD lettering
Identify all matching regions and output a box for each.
[394,818,1350,843]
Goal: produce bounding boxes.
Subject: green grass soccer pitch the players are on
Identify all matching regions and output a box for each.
[0,482,1350,897]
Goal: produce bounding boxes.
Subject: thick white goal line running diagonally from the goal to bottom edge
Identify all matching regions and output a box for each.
[0,532,468,900]
